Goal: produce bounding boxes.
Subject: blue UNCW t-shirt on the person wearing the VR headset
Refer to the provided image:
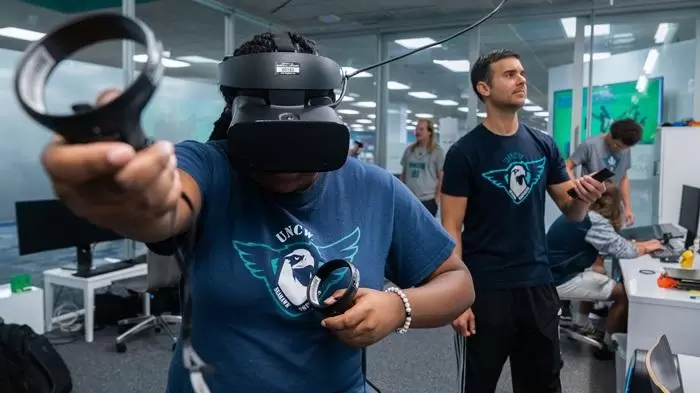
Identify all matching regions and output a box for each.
[168,141,454,393]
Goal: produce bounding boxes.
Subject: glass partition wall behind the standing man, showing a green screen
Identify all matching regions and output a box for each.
[370,5,700,230]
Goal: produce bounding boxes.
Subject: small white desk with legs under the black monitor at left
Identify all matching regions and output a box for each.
[44,263,148,343]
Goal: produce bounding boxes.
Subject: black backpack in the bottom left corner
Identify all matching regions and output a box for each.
[0,321,73,393]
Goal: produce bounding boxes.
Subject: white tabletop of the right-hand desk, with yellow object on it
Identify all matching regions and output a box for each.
[620,255,700,310]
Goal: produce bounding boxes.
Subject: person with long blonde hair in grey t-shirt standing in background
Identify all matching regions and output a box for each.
[401,119,445,216]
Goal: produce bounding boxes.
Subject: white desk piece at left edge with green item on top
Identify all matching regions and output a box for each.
[0,284,44,334]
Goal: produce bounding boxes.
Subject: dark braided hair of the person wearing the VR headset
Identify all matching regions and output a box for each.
[209,32,317,141]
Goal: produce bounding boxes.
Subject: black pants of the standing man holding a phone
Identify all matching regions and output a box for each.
[456,285,561,393]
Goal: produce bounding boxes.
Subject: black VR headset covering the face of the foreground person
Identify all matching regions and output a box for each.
[219,33,350,172]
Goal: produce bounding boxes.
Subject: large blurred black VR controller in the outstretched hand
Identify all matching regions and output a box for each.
[14,13,163,149]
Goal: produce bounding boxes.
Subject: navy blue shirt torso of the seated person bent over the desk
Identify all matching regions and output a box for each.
[547,215,598,286]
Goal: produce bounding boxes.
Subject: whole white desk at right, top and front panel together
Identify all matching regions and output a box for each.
[620,256,700,364]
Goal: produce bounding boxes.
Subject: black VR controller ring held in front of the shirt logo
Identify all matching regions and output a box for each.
[307,259,360,317]
